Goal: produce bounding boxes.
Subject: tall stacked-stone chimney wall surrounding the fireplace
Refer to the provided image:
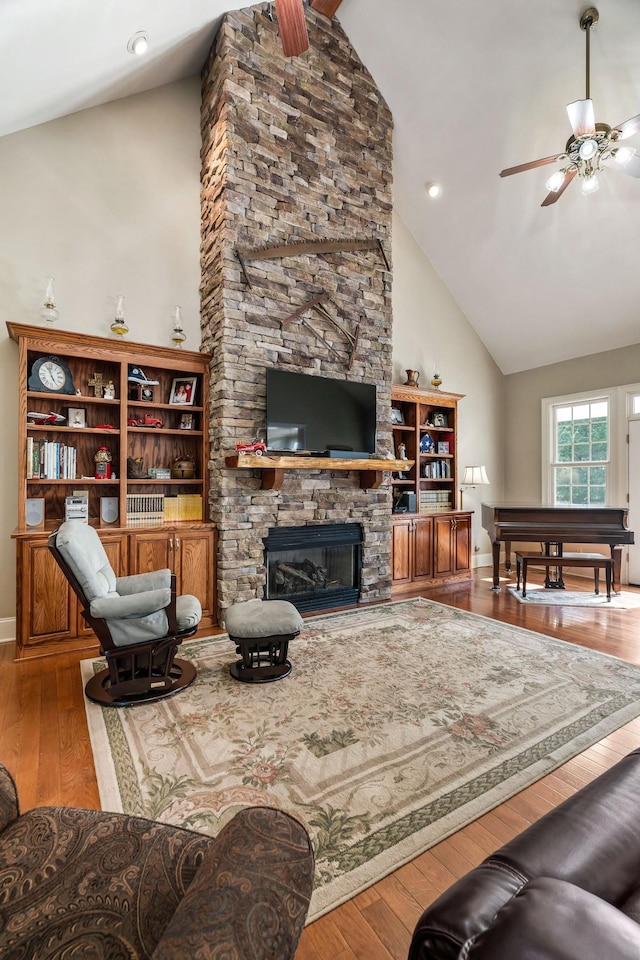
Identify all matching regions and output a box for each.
[201,3,392,610]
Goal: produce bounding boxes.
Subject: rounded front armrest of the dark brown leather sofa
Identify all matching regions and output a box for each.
[465,877,640,960]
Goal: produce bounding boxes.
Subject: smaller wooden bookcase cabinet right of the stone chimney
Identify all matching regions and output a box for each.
[391,386,471,594]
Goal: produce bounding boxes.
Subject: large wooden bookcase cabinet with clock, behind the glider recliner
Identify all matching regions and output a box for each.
[7,323,216,657]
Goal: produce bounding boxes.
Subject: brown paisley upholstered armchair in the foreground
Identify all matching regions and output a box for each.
[0,764,314,960]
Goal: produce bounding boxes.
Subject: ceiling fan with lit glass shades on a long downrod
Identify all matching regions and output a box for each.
[500,7,640,207]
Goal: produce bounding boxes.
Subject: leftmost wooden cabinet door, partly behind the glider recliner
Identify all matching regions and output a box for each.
[16,537,77,650]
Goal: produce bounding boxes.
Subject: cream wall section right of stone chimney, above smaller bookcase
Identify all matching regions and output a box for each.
[393,210,505,563]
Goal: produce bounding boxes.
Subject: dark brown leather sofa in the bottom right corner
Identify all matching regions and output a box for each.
[409,749,640,960]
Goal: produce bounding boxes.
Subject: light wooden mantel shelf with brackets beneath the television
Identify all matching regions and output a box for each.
[225,453,415,490]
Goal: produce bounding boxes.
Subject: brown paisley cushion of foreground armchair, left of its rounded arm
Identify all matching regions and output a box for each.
[0,807,214,960]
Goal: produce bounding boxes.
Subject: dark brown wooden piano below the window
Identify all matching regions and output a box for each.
[482,503,635,590]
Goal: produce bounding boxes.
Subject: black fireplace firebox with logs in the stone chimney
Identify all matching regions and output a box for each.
[264,523,362,613]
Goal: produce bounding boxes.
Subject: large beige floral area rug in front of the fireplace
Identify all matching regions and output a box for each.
[82,599,640,921]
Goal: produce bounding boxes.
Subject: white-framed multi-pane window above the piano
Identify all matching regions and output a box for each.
[551,398,610,506]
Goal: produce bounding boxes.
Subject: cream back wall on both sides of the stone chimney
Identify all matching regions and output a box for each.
[0,77,503,640]
